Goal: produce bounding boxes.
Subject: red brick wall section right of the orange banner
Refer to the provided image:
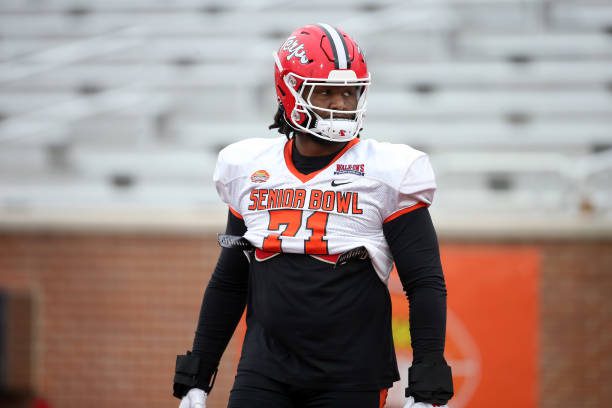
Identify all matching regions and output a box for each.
[540,242,612,408]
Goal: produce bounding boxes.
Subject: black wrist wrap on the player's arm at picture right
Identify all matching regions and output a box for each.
[406,362,453,405]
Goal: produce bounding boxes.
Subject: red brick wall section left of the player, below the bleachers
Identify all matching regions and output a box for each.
[0,234,235,408]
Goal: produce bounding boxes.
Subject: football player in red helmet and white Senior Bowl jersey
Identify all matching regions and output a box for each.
[174,24,453,408]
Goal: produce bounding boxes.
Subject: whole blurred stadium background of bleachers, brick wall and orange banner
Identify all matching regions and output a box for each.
[0,0,612,408]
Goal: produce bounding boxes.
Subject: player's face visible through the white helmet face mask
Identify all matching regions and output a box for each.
[305,85,359,119]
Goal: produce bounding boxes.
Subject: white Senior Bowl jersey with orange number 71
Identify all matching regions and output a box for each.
[214,136,436,284]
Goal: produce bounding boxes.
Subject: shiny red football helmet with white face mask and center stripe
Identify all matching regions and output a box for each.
[274,23,370,142]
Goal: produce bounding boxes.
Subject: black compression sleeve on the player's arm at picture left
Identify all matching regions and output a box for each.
[193,212,249,390]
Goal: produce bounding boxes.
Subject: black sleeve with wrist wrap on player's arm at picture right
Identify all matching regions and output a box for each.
[383,207,453,404]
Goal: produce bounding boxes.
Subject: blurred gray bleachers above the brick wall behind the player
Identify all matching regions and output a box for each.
[0,0,612,228]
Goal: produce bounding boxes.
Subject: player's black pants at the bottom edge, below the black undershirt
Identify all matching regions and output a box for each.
[228,371,387,408]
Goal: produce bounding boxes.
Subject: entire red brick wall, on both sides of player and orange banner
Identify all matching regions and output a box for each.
[0,232,612,408]
